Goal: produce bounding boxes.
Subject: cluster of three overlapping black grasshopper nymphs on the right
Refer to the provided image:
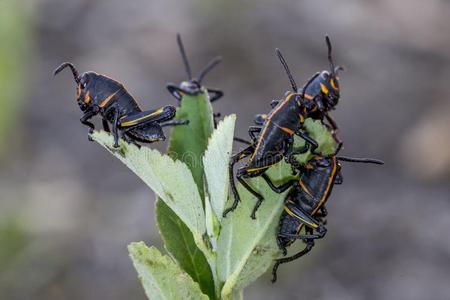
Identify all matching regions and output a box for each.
[224,36,383,282]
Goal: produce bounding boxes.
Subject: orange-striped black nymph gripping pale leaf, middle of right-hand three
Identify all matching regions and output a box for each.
[224,45,326,218]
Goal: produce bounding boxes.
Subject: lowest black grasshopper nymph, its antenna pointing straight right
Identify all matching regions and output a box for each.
[263,155,383,282]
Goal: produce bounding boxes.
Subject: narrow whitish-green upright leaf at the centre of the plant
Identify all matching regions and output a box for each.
[203,115,236,222]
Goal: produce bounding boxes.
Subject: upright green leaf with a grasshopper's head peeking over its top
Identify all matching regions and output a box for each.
[168,90,214,199]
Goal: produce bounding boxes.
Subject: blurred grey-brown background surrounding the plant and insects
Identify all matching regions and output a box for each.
[0,0,450,300]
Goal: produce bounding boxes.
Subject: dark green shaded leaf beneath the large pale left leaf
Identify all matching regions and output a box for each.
[156,199,216,299]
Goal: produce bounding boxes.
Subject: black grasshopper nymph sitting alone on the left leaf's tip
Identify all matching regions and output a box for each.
[54,62,188,148]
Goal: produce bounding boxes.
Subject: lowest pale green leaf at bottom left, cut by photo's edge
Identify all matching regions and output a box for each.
[128,242,208,300]
